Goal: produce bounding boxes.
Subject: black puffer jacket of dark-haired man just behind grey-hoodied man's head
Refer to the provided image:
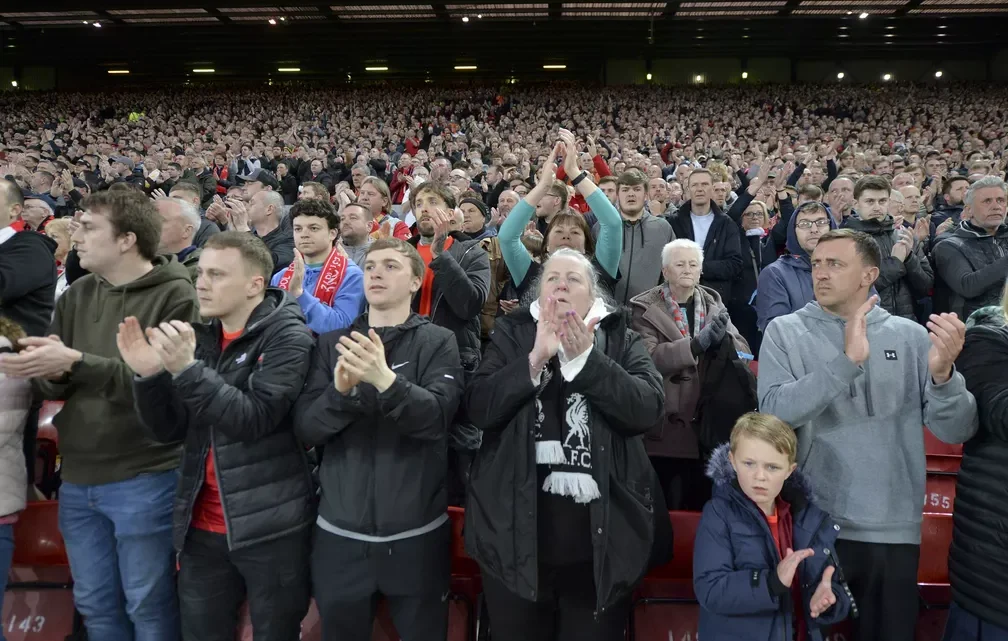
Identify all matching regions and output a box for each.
[842,213,931,321]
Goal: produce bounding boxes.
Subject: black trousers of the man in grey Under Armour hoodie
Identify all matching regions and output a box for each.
[837,540,920,641]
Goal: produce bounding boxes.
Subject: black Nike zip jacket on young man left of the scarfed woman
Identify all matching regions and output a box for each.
[294,312,463,536]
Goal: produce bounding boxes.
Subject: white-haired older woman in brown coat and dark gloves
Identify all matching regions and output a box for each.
[630,238,749,510]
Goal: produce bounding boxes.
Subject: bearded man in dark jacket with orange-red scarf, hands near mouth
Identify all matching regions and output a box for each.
[410,182,490,371]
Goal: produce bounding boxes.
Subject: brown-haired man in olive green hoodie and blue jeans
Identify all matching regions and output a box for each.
[0,191,199,641]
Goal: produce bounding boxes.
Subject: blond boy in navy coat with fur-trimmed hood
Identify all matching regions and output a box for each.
[694,412,857,641]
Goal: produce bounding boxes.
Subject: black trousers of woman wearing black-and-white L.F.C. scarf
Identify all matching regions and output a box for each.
[483,562,630,641]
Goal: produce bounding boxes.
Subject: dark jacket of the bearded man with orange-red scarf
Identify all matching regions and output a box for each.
[410,232,490,371]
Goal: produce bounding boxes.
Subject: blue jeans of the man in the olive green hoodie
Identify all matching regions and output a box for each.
[59,470,180,641]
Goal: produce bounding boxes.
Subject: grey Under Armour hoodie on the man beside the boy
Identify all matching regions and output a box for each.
[757,302,978,544]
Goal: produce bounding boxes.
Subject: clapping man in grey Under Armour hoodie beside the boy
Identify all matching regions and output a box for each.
[758,230,978,641]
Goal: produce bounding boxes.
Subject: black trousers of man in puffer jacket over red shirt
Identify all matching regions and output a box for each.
[178,528,311,641]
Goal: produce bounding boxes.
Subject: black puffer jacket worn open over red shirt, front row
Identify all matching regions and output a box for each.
[133,288,314,550]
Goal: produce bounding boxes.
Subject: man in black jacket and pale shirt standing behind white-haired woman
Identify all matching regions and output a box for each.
[668,169,745,300]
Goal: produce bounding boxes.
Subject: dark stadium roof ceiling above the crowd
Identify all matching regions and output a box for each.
[0,0,1008,80]
